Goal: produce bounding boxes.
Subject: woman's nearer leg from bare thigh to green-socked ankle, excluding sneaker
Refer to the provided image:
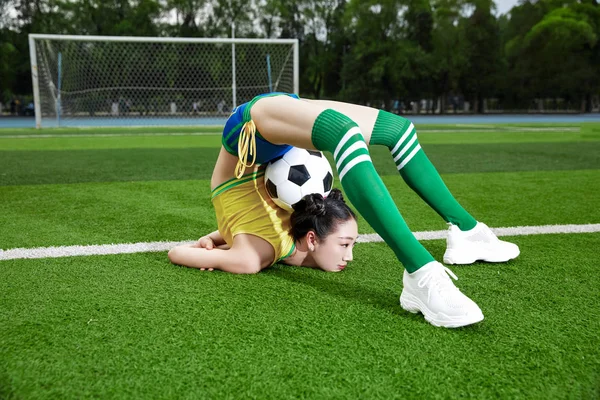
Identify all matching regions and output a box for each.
[251,96,434,272]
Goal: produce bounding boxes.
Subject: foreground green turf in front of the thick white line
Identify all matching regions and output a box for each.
[0,233,600,398]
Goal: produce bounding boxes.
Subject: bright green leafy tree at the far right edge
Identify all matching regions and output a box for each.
[506,1,600,109]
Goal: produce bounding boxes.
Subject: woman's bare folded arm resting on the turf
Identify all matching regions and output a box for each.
[169,234,275,274]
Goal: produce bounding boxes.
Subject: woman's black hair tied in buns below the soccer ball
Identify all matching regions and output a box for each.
[291,189,356,241]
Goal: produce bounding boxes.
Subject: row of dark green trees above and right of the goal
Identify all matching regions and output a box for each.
[0,0,600,111]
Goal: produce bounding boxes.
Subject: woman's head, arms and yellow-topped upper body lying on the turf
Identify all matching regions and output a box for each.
[169,188,358,274]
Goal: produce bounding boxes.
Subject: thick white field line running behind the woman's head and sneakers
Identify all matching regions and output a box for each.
[0,224,600,260]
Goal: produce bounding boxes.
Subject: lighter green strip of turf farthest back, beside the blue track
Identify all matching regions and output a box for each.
[0,125,600,151]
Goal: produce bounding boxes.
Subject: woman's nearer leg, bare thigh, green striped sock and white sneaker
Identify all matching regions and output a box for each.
[251,96,483,327]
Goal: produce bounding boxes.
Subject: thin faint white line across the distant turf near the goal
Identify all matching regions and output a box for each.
[0,125,580,139]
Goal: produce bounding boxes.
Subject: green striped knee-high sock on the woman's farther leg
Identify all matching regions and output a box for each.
[370,110,477,231]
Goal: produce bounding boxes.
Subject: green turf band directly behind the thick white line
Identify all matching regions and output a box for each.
[0,170,600,248]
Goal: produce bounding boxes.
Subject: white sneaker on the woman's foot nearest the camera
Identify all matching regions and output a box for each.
[400,261,483,328]
